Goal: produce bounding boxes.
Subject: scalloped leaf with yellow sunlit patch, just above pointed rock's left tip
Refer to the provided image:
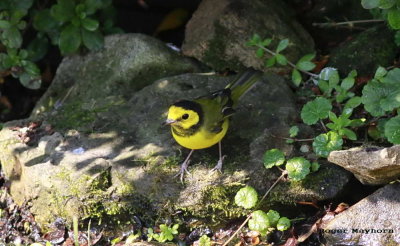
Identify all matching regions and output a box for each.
[313,131,343,157]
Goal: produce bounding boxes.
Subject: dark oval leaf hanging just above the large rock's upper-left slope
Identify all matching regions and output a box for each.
[59,24,82,54]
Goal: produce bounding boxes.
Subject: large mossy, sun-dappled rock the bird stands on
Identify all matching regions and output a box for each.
[0,35,344,230]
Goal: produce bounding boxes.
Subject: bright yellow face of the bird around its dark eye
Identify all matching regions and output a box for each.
[166,105,200,129]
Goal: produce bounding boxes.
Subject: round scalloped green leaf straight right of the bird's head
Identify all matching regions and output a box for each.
[301,97,332,125]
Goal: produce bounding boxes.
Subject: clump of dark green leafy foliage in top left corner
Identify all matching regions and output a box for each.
[0,0,120,89]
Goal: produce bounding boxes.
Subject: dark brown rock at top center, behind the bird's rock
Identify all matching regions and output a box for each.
[182,0,314,71]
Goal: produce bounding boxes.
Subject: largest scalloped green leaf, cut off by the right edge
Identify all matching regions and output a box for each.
[361,68,400,117]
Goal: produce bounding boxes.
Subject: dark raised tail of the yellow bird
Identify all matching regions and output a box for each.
[225,68,263,104]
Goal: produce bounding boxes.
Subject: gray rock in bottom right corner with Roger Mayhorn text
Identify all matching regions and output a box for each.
[322,183,400,246]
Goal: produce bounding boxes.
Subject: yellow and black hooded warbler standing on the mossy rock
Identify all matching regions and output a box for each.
[164,69,262,181]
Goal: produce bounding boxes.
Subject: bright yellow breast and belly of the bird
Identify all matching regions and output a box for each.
[171,119,229,149]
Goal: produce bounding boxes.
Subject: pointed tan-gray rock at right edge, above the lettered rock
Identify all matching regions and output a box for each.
[328,145,400,185]
